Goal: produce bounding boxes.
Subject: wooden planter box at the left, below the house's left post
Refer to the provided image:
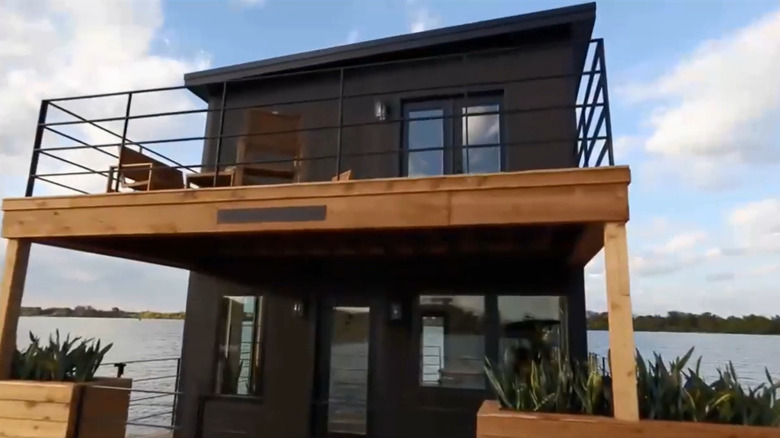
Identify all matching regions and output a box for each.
[0,378,132,438]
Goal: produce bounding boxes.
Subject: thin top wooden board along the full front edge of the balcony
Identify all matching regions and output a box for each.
[2,166,631,212]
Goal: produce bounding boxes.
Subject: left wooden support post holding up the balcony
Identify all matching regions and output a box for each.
[0,239,30,380]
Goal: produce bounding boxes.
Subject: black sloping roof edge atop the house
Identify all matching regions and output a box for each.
[184,3,596,98]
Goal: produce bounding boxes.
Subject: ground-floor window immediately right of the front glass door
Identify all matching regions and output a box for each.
[419,295,485,389]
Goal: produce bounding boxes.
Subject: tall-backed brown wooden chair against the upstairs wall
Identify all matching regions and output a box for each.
[187,109,301,187]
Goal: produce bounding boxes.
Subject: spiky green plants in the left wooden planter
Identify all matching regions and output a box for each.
[12,330,113,382]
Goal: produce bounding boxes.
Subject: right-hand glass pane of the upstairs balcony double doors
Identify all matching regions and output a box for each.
[463,105,501,173]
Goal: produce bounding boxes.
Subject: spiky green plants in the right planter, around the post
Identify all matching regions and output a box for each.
[485,348,780,427]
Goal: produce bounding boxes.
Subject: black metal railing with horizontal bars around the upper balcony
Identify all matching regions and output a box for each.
[25,39,614,196]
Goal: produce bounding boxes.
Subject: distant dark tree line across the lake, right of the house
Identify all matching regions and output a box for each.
[588,312,780,335]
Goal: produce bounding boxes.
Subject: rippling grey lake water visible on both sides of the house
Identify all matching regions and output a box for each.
[18,317,780,433]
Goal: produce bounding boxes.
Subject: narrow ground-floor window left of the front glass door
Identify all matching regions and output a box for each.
[216,296,263,395]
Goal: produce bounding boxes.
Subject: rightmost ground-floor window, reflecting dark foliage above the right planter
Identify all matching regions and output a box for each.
[498,296,563,362]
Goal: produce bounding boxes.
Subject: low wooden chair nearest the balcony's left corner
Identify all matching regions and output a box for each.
[106,146,184,192]
